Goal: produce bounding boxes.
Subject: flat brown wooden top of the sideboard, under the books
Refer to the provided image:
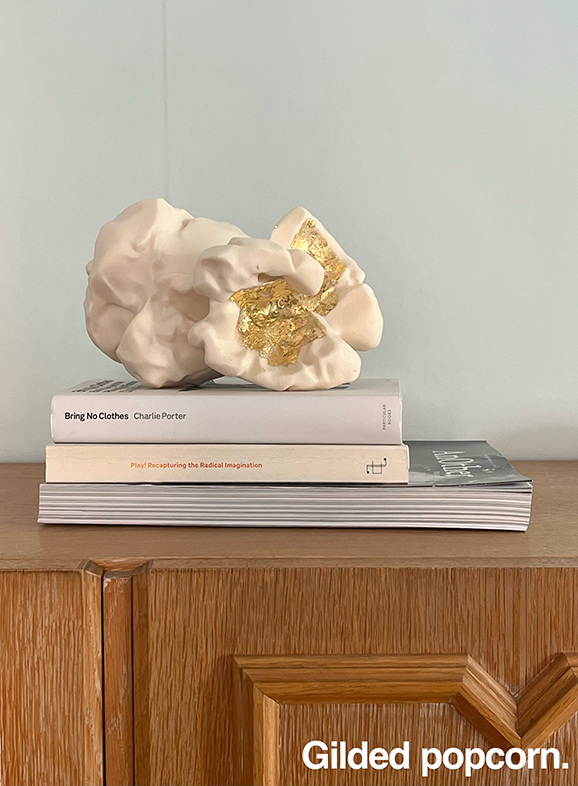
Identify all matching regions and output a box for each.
[0,461,578,568]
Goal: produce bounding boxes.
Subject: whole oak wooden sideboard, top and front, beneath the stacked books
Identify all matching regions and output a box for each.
[0,462,578,786]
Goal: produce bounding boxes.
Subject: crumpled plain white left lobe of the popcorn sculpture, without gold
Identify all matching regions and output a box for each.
[84,199,244,388]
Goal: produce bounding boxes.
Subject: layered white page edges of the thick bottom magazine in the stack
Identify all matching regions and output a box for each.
[39,480,532,530]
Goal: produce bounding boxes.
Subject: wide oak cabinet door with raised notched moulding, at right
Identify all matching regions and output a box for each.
[132,564,578,786]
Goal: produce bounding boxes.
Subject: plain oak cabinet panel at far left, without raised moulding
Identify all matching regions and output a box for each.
[0,565,103,786]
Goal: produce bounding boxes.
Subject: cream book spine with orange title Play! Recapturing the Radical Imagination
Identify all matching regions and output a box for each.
[46,445,409,483]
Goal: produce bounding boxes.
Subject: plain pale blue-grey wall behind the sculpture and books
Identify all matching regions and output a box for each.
[0,0,578,460]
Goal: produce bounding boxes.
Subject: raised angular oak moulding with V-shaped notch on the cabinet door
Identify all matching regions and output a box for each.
[234,653,578,786]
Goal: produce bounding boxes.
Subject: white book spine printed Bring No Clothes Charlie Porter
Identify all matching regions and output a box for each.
[51,391,402,445]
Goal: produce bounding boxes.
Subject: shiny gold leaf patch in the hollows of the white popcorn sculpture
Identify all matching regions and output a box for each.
[231,219,345,366]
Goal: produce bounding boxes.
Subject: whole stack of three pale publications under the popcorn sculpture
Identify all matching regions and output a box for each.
[39,380,532,529]
